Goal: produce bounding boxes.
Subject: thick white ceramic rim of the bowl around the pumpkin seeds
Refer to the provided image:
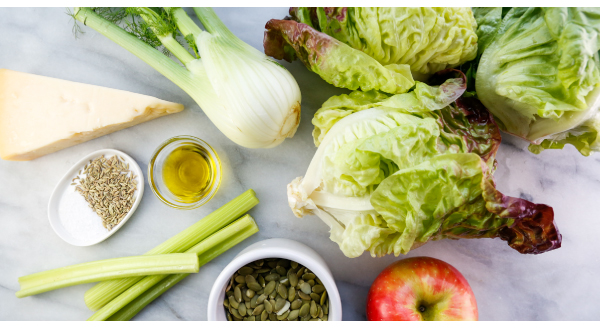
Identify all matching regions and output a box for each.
[208,238,342,321]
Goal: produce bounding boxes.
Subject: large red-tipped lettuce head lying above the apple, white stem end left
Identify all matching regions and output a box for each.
[288,71,561,257]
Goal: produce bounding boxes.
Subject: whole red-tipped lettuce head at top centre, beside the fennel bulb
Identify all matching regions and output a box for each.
[264,7,477,94]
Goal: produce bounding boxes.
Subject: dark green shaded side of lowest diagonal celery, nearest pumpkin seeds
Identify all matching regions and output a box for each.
[108,220,258,321]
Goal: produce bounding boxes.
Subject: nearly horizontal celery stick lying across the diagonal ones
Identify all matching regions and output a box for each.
[16,254,200,298]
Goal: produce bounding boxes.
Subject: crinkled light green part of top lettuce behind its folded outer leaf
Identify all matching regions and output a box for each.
[290,7,477,77]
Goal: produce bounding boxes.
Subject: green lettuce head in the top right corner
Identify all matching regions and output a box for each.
[474,8,600,155]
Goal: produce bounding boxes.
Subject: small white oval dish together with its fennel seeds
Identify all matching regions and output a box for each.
[48,149,144,246]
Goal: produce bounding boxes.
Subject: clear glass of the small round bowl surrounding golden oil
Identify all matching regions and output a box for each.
[148,135,221,210]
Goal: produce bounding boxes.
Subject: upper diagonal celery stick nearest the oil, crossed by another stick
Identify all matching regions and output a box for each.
[85,190,258,311]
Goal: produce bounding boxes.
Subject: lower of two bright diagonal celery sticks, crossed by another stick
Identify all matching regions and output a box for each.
[88,214,258,321]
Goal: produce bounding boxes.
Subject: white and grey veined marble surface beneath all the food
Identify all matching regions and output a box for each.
[0,8,600,320]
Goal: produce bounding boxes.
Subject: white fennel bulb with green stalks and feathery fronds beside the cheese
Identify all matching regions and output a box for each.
[73,8,301,148]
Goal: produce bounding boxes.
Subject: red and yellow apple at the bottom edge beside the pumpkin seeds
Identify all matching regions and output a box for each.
[367,257,478,321]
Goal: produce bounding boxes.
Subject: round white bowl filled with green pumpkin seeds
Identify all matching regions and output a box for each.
[208,238,342,321]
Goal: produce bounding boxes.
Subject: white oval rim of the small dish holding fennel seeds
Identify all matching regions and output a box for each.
[48,149,144,246]
